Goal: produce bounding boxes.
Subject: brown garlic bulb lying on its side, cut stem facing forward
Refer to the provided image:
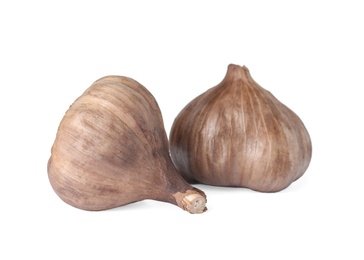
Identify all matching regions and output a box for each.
[48,76,206,213]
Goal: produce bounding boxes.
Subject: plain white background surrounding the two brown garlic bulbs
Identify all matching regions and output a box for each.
[0,0,364,259]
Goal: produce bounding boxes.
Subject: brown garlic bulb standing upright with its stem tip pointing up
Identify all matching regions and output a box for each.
[170,64,312,192]
